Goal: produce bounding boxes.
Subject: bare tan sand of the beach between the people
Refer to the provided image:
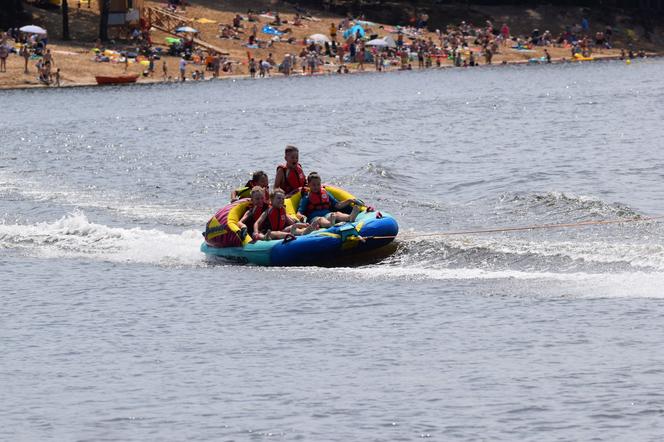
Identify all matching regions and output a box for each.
[0,0,657,89]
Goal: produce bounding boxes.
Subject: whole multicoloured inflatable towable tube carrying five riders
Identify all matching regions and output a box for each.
[201,185,399,266]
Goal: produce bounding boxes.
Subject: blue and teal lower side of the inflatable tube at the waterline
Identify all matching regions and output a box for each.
[201,212,399,266]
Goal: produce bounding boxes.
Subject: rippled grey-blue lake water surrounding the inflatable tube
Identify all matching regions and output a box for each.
[0,60,664,441]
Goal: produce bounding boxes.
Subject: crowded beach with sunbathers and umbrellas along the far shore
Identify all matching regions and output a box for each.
[0,0,651,88]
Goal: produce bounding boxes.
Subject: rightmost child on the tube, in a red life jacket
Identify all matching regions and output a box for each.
[297,172,361,229]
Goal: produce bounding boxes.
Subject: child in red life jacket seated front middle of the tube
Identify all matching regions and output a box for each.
[252,189,313,241]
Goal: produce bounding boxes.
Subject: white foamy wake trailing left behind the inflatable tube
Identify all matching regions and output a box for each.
[0,212,204,266]
